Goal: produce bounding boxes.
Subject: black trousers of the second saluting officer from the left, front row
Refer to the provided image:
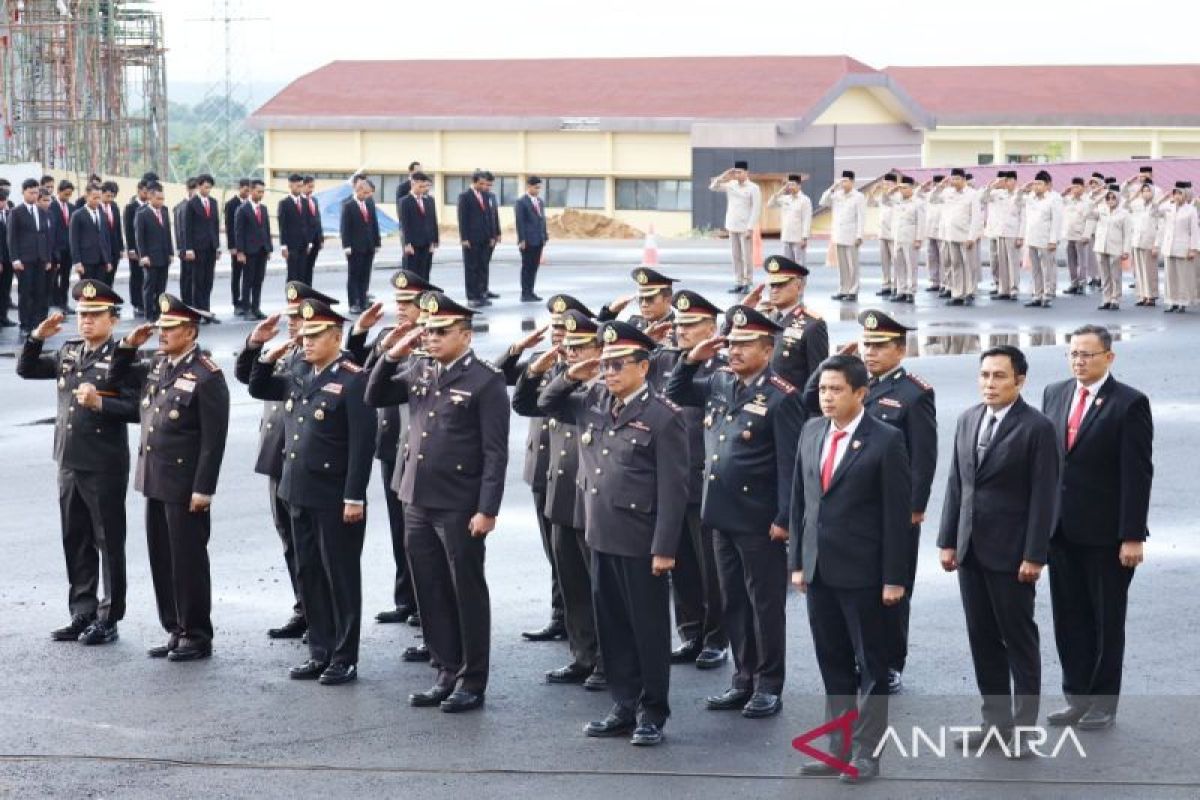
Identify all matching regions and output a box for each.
[146,498,212,645]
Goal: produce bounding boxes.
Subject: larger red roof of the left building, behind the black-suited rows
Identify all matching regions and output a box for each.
[254,56,876,119]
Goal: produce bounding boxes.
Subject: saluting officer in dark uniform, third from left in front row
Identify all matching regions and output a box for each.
[250,299,376,686]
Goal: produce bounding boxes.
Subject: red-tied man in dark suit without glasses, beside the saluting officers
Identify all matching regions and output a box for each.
[788,355,912,783]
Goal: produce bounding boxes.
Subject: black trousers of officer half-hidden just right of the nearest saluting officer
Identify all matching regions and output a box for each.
[671,505,724,650]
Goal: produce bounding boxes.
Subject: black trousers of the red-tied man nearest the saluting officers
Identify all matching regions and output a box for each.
[806,575,888,760]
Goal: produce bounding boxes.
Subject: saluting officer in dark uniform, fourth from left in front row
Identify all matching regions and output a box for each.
[366,291,509,714]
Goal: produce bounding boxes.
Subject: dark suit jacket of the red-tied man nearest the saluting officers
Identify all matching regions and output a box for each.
[788,414,912,590]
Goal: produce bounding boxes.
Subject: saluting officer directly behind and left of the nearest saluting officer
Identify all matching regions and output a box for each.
[512,307,607,691]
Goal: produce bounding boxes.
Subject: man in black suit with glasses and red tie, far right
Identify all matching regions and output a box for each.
[1042,325,1154,730]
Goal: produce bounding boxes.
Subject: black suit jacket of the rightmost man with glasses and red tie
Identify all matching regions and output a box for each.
[1042,374,1154,546]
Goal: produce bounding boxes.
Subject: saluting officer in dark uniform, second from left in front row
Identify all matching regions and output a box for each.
[110,294,229,661]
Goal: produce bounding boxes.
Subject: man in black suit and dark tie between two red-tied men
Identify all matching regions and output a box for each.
[937,344,1060,758]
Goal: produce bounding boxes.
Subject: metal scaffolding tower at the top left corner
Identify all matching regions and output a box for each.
[0,0,167,175]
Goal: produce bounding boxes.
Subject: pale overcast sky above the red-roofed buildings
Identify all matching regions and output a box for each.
[157,0,1200,102]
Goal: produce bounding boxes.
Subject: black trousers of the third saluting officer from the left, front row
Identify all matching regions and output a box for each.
[288,504,367,664]
